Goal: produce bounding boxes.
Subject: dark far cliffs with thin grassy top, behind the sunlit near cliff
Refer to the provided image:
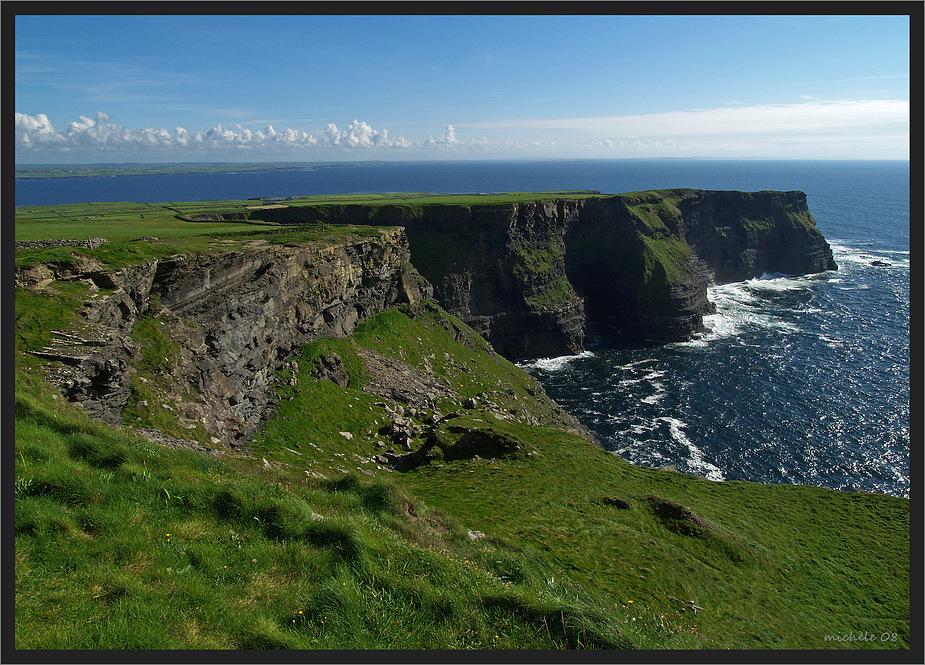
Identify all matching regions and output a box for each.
[259,189,836,358]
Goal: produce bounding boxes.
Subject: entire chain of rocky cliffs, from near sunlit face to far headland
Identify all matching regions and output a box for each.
[16,190,835,445]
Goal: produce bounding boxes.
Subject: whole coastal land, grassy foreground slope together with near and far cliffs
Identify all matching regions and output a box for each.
[14,193,908,660]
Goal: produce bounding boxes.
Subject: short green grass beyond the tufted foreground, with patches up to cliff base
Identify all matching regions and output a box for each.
[253,310,910,649]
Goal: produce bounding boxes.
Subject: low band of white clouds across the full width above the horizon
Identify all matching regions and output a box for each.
[15,100,909,163]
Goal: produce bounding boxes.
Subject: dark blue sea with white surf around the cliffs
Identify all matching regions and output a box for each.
[16,160,910,497]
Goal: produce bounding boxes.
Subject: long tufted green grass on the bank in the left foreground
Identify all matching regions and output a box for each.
[15,366,672,650]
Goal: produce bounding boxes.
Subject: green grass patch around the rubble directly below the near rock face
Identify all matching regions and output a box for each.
[245,304,564,476]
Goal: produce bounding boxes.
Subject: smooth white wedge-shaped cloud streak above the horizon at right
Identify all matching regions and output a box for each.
[457,100,909,159]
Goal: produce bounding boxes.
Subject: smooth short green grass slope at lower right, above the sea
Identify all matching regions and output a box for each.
[401,422,910,649]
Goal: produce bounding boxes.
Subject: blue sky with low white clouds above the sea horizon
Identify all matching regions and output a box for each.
[14,13,921,164]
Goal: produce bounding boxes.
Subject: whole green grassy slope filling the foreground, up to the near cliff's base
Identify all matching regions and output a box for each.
[15,195,909,649]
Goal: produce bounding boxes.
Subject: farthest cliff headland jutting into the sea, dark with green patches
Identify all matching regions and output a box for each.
[566,190,837,341]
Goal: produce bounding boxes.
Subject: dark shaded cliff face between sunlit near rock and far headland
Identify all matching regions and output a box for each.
[402,200,586,358]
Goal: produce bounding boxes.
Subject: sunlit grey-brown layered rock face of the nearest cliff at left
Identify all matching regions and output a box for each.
[24,229,432,444]
